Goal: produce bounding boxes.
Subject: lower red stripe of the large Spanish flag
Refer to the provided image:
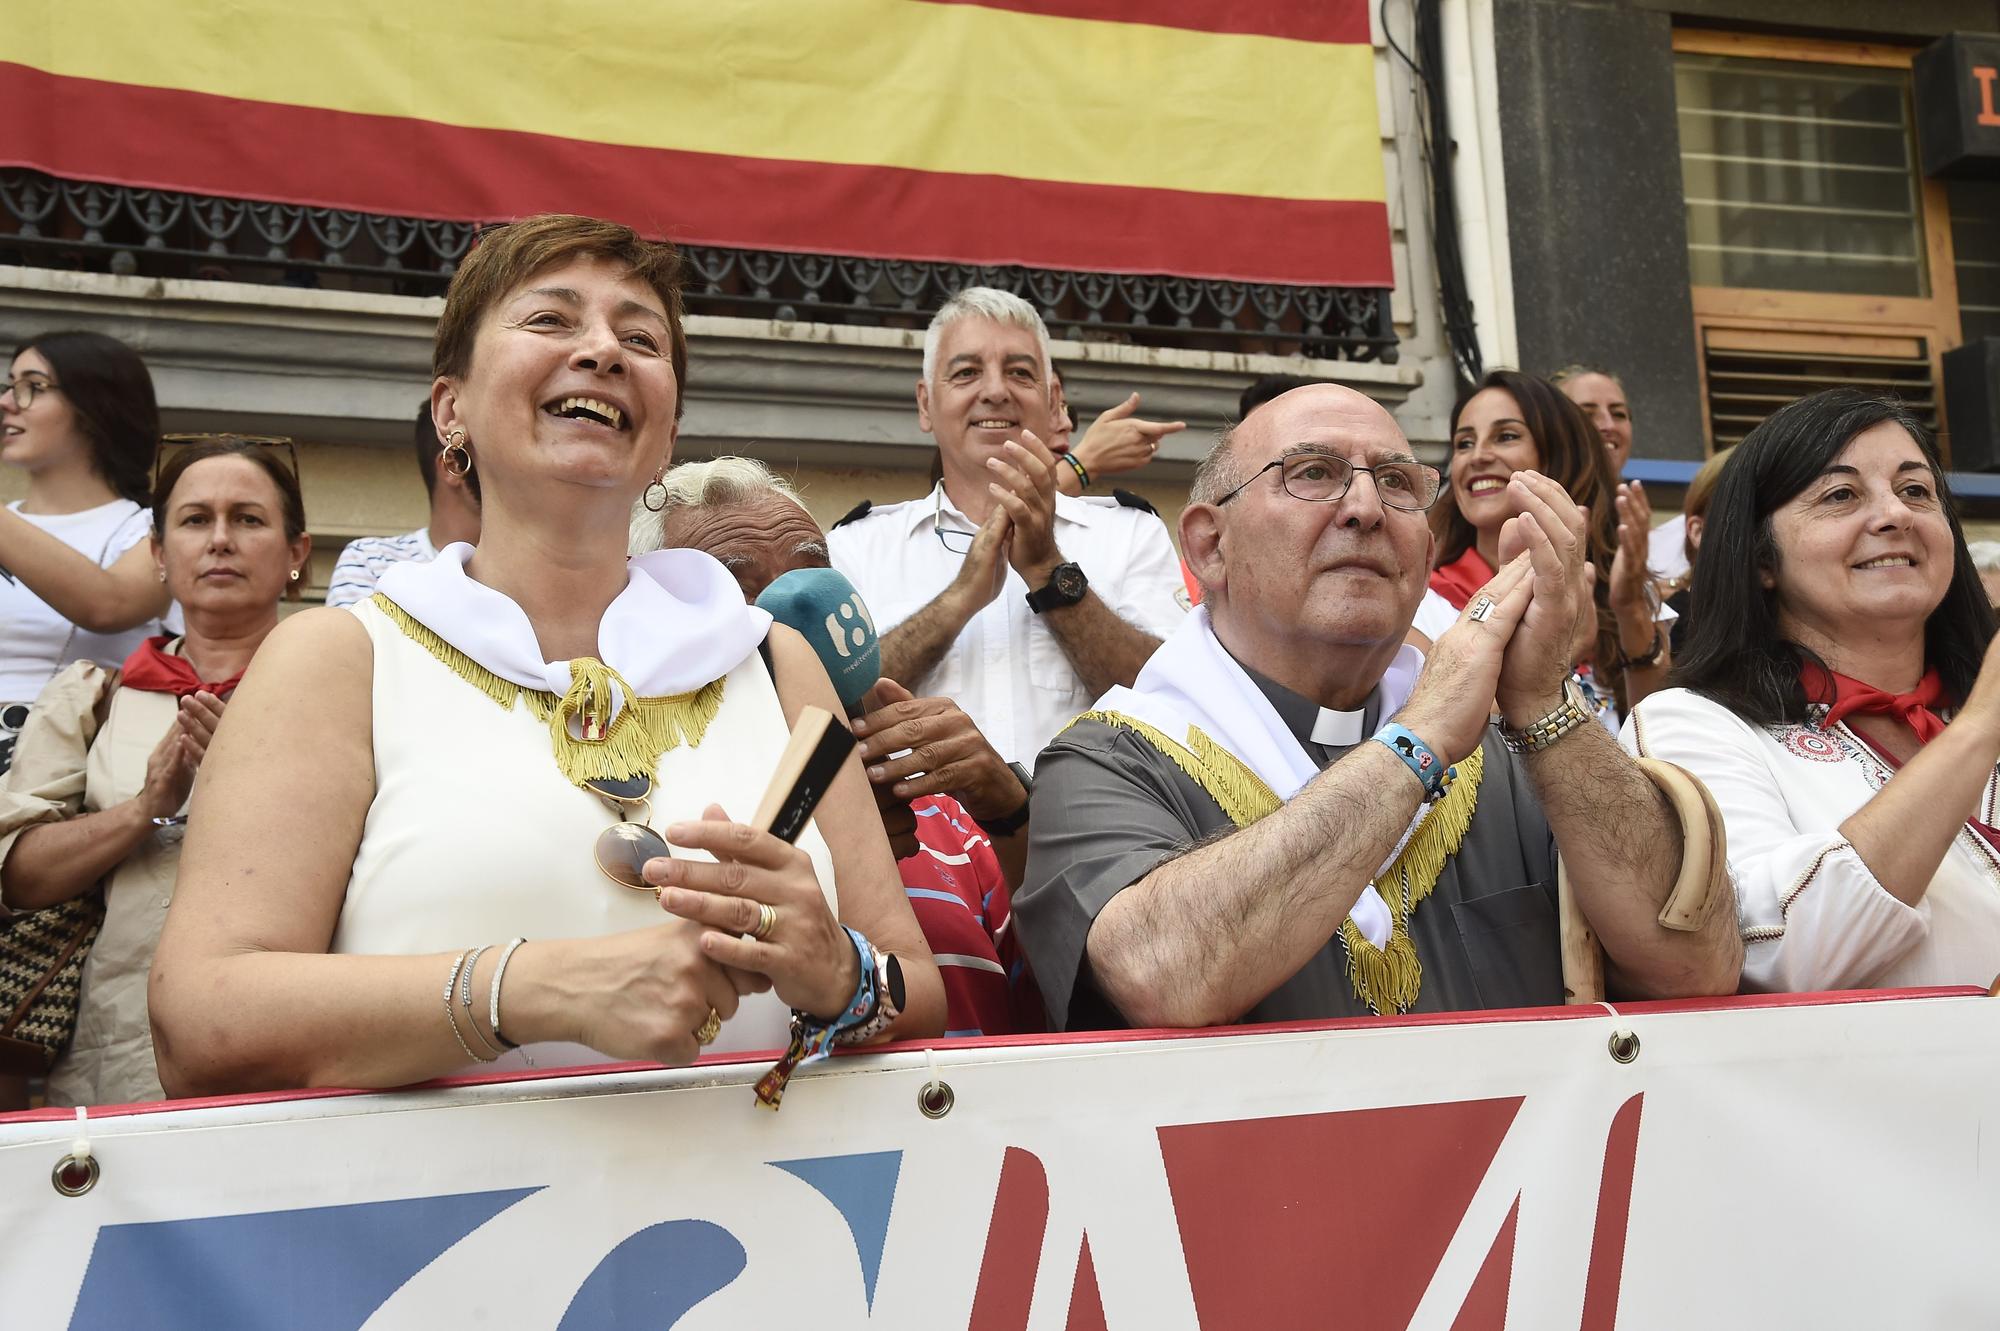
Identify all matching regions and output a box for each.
[0,62,1394,286]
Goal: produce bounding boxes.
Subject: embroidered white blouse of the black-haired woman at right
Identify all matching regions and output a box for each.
[1620,689,2000,993]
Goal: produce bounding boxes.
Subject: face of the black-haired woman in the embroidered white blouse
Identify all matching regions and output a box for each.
[1764,422,1956,656]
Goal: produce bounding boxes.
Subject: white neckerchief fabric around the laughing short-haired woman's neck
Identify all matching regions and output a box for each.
[376,542,770,705]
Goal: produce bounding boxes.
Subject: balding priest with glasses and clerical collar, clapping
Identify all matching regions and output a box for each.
[1014,384,1742,1029]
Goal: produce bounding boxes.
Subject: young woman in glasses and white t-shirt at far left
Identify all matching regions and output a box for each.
[0,332,168,771]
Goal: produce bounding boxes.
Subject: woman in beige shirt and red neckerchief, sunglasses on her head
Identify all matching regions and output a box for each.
[0,440,312,1105]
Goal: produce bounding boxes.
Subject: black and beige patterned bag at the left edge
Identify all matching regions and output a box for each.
[0,889,104,1077]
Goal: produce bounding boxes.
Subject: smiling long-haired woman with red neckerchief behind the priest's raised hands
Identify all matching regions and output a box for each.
[1418,370,1674,725]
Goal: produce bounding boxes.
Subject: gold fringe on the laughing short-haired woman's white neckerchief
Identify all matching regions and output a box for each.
[372,592,728,785]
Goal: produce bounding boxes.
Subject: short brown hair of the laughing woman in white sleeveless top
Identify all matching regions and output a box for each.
[430,212,688,420]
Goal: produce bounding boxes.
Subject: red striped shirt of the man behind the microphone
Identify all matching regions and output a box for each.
[896,795,1048,1035]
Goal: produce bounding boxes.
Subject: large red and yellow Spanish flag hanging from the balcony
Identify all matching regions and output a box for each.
[0,0,1392,286]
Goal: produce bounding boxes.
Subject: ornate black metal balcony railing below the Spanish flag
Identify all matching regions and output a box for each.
[0,170,1396,364]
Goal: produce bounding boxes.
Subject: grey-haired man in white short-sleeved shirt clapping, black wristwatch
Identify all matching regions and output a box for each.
[828,288,1184,765]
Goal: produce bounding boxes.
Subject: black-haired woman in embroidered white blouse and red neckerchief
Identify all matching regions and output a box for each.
[1624,390,2000,991]
